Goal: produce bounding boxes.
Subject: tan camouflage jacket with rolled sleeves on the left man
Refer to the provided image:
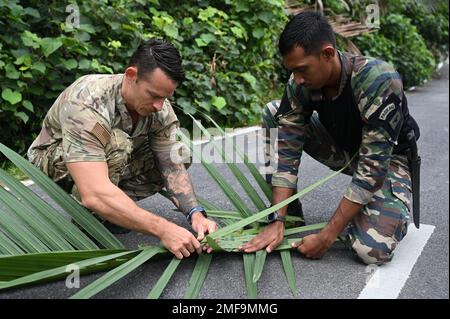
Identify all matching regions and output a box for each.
[28,74,179,169]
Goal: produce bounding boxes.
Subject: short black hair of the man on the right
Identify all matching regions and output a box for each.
[278,11,336,56]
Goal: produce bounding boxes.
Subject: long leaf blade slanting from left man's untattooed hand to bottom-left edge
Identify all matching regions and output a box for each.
[70,247,166,299]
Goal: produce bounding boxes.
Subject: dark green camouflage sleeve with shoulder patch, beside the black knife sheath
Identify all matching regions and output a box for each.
[344,61,403,205]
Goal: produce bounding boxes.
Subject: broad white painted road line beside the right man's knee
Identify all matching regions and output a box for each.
[358,223,435,299]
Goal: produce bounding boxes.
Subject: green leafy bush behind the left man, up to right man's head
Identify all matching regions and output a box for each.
[0,0,287,162]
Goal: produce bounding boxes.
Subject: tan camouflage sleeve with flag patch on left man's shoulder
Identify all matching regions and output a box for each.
[60,102,110,163]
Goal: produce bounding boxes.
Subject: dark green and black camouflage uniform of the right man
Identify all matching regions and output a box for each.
[263,51,412,264]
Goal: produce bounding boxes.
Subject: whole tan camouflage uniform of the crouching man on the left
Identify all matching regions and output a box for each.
[28,74,186,200]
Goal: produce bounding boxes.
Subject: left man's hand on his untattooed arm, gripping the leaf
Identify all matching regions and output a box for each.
[160,221,202,259]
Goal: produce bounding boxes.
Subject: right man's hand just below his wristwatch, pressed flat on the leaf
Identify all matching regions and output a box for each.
[239,221,284,253]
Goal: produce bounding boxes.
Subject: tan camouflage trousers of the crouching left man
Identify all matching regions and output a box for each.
[30,129,169,201]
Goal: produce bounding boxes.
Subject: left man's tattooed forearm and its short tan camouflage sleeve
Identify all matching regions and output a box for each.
[149,100,198,215]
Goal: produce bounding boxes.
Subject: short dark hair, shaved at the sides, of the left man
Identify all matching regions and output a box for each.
[128,38,184,83]
